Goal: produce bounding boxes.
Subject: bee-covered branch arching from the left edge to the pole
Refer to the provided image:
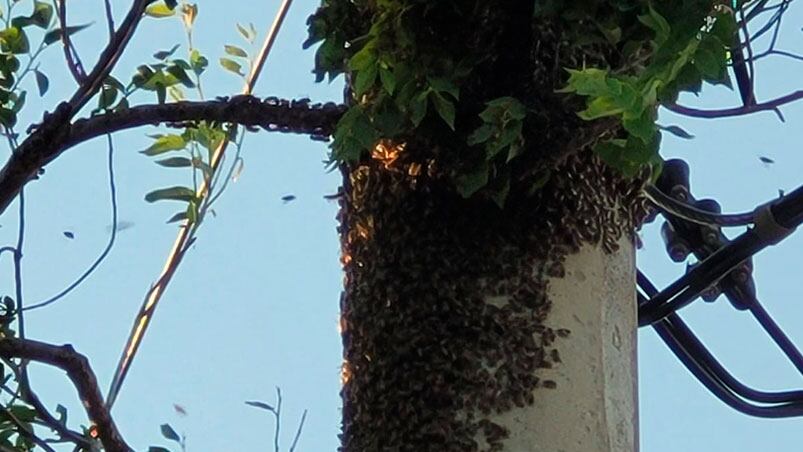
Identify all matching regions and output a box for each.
[0,95,344,214]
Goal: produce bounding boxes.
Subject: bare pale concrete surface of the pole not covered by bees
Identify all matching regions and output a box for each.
[481,239,638,452]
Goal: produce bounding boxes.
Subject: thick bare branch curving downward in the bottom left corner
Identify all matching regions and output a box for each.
[0,338,133,452]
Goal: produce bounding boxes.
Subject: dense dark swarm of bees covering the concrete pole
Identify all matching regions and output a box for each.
[339,142,642,452]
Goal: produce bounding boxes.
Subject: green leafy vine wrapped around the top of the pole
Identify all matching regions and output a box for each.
[305,0,741,205]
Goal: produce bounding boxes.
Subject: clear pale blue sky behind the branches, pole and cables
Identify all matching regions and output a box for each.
[0,0,803,452]
